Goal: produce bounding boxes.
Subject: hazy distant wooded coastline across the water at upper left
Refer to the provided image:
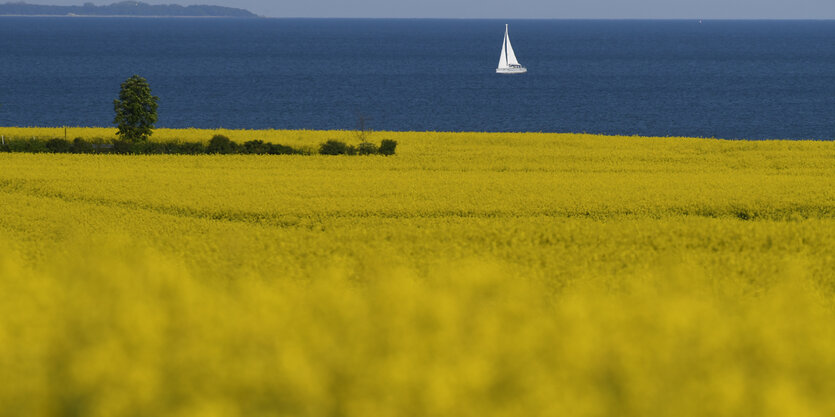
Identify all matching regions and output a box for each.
[0,1,258,17]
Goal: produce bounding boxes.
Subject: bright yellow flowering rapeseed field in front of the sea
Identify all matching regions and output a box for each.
[0,128,835,417]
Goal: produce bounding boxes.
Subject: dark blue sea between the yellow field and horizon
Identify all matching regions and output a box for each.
[0,17,835,139]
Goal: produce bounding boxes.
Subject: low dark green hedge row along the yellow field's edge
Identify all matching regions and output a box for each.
[0,135,397,155]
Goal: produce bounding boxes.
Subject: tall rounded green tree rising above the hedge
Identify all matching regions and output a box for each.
[113,75,159,142]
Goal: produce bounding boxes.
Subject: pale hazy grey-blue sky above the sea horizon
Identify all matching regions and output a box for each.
[29,0,835,19]
